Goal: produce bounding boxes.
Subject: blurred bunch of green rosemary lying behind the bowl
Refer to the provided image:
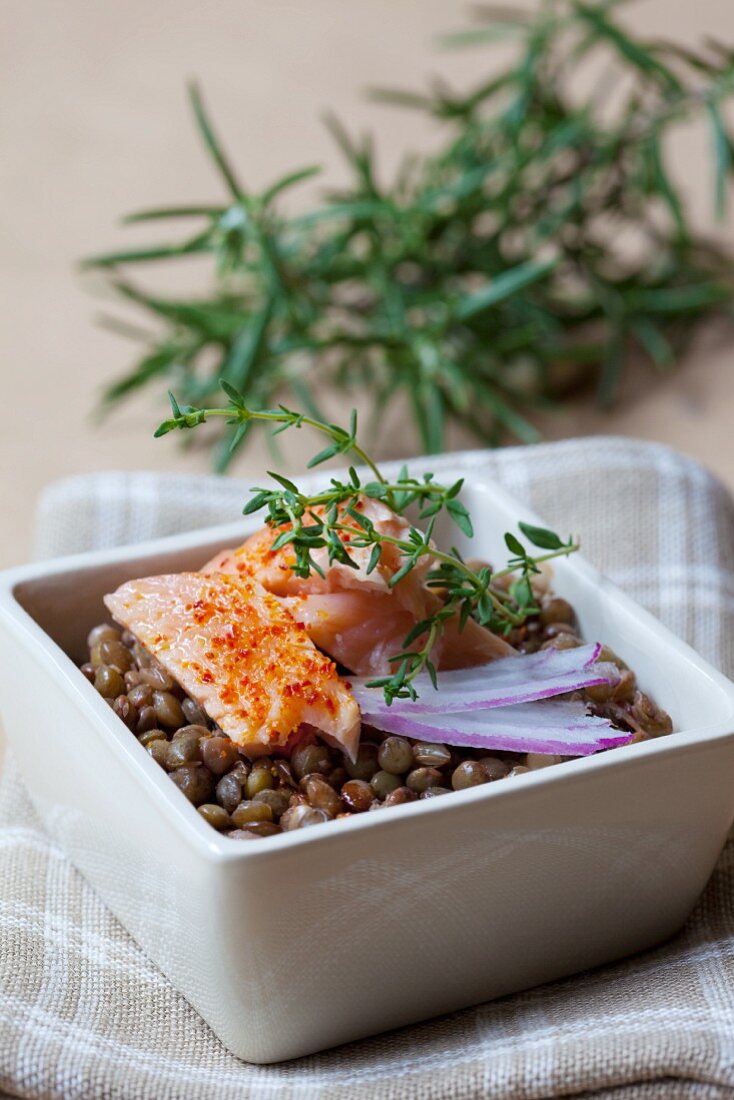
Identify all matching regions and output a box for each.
[87,0,734,470]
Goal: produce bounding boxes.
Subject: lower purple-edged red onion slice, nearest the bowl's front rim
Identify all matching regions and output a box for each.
[362,703,633,756]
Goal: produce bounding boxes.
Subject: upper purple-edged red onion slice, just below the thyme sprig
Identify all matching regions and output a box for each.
[348,644,620,712]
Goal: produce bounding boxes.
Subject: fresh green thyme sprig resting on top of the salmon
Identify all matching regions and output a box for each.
[155,383,579,703]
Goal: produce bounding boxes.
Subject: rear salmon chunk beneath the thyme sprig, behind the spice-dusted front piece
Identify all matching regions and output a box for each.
[202,499,514,675]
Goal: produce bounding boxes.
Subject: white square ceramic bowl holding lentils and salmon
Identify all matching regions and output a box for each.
[0,471,734,1063]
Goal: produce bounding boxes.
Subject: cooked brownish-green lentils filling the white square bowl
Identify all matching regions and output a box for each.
[81,594,672,840]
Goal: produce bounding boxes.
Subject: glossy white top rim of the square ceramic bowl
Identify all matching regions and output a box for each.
[0,463,734,864]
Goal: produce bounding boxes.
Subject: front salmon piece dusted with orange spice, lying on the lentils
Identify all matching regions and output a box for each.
[105,573,360,757]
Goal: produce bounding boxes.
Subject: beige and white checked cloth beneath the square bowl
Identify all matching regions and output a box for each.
[0,439,734,1100]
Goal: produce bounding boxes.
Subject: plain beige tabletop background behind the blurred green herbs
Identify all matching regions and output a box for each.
[0,0,734,580]
